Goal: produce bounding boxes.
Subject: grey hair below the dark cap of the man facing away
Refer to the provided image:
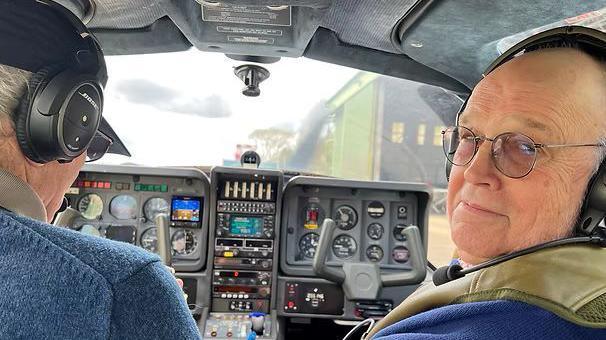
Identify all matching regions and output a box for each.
[0,64,32,128]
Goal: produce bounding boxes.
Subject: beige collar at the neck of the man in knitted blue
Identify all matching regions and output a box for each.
[0,169,46,222]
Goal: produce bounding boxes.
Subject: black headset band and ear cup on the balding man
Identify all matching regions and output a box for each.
[446,26,606,235]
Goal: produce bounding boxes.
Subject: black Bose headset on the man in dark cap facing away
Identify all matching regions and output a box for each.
[0,0,111,163]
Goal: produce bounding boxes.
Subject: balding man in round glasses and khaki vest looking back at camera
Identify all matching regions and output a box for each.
[365,27,606,340]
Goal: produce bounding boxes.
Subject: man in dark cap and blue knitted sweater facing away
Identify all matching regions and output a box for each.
[0,0,200,339]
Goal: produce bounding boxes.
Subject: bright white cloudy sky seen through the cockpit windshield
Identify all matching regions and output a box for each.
[99,50,359,166]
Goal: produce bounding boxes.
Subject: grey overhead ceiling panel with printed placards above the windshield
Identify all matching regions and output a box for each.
[167,1,327,57]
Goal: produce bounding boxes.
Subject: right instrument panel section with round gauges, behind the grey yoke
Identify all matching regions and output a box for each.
[281,177,427,276]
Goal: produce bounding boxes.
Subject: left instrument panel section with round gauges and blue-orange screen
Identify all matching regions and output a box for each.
[66,166,210,271]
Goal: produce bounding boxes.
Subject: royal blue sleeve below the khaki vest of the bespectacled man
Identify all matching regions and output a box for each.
[373,300,606,340]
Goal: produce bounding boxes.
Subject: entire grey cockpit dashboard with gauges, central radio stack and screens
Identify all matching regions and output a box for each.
[66,165,430,337]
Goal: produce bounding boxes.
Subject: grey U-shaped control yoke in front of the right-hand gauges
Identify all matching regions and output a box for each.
[313,218,427,300]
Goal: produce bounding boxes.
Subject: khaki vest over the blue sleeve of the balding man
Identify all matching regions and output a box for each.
[364,245,606,339]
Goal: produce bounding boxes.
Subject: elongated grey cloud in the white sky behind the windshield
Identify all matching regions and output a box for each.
[116,79,232,118]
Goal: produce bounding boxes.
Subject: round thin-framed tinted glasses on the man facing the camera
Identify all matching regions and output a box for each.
[442,125,605,178]
